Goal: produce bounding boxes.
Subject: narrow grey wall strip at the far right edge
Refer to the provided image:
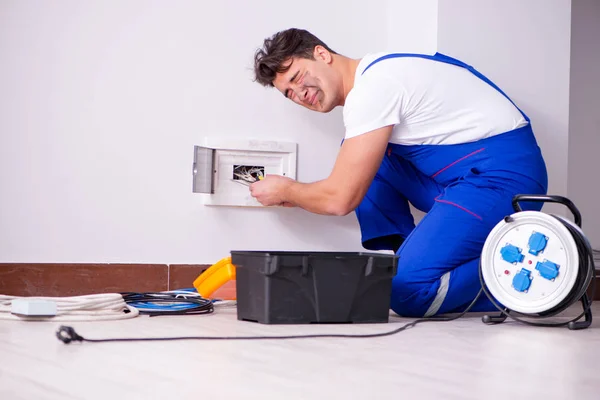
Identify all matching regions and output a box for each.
[568,0,600,248]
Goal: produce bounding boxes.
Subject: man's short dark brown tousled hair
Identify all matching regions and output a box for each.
[254,28,337,86]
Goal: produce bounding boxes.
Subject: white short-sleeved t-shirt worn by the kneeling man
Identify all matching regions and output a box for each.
[343,53,527,145]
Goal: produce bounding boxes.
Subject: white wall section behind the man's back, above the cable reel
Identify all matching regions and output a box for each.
[438,0,572,215]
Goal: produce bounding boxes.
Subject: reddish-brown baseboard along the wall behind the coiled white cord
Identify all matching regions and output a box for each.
[0,263,210,296]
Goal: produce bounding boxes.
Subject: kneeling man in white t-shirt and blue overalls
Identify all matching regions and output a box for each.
[250,29,548,317]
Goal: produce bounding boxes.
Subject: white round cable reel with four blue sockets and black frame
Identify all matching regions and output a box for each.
[479,195,596,330]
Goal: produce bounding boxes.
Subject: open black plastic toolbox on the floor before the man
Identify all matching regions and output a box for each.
[231,251,398,324]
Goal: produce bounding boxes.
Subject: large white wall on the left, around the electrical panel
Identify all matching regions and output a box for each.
[0,0,435,263]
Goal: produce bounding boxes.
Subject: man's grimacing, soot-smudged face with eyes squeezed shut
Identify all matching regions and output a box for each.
[273,46,341,113]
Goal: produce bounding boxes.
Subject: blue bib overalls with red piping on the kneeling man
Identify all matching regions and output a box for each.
[356,53,548,317]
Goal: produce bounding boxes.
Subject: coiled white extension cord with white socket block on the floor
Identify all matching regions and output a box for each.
[0,293,139,321]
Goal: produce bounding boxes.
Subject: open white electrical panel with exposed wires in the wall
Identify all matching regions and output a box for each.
[192,138,297,207]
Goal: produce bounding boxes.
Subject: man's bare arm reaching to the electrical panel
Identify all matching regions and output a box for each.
[251,125,393,215]
